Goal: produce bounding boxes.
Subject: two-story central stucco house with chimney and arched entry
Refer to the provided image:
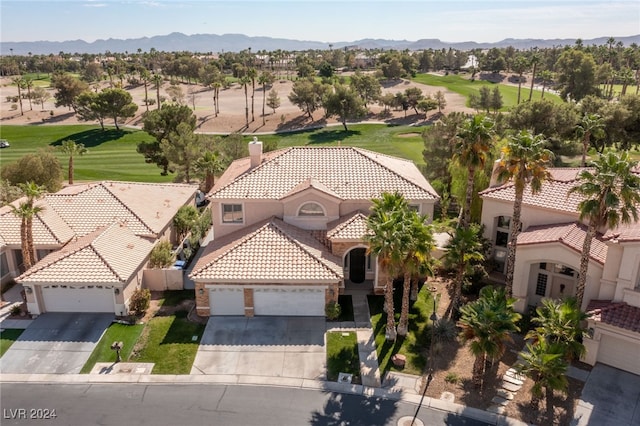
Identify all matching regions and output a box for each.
[191,140,438,316]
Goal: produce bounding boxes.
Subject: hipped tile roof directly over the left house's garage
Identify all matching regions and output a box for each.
[16,223,153,283]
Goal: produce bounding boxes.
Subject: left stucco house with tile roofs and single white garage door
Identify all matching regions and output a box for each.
[0,181,197,315]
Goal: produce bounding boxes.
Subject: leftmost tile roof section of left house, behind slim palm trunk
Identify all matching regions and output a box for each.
[0,199,75,246]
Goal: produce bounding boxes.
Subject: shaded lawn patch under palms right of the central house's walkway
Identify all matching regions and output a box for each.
[369,286,433,375]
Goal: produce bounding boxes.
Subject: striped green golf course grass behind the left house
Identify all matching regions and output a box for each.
[0,124,173,182]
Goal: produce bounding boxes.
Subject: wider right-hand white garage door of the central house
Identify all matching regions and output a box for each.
[253,287,324,316]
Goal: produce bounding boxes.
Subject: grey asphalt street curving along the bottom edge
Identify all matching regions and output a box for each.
[0,383,488,426]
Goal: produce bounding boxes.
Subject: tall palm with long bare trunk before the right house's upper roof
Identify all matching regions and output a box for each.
[496,130,554,297]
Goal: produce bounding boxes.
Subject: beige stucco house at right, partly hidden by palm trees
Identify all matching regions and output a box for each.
[480,168,640,374]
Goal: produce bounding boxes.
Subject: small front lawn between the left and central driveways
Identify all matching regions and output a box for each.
[130,312,205,374]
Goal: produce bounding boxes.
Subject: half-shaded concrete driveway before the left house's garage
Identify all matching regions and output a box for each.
[0,313,113,374]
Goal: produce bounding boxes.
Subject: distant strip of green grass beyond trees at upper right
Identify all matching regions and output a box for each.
[412,74,562,111]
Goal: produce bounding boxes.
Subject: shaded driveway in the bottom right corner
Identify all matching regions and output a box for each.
[571,364,640,426]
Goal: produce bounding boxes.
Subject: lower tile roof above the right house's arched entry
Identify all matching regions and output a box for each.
[518,222,607,265]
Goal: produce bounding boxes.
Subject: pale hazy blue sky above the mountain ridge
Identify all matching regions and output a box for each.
[0,0,640,43]
